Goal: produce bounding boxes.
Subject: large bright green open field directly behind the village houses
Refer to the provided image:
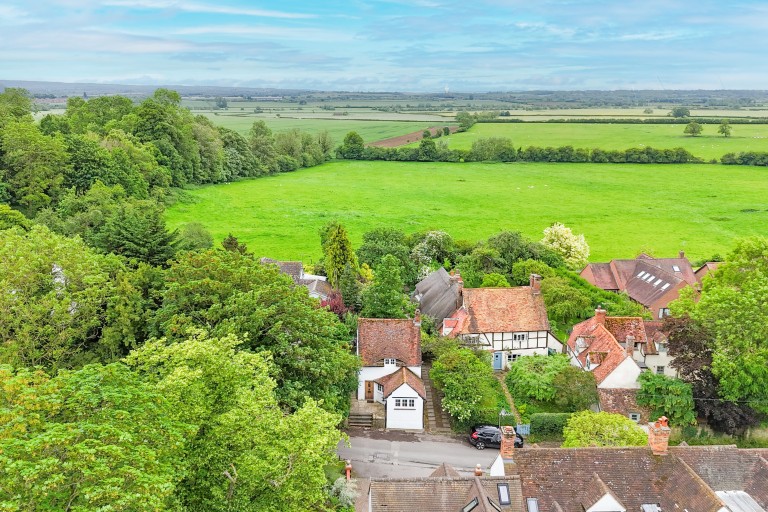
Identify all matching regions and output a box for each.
[166,161,768,262]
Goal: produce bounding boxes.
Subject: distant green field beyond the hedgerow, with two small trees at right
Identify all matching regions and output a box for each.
[424,123,768,160]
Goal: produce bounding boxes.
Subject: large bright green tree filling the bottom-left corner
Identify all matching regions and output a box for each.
[0,363,190,512]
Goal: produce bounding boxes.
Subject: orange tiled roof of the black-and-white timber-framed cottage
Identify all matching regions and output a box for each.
[446,286,550,336]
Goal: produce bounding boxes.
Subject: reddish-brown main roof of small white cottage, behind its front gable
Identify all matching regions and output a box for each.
[357,318,421,366]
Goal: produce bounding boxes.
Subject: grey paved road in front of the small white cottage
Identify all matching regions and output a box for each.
[337,429,499,478]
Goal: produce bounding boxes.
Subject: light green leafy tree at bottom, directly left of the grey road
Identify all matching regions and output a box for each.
[127,332,342,512]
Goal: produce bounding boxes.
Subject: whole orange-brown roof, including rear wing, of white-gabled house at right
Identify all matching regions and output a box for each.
[568,316,647,385]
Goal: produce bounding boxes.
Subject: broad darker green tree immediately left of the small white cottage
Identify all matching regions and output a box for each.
[153,250,359,411]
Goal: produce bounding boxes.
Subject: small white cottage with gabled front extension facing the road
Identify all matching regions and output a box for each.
[357,311,426,430]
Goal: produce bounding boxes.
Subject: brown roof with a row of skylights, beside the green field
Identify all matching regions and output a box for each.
[581,254,700,306]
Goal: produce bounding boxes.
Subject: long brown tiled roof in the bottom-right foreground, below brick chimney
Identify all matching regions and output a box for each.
[505,447,722,512]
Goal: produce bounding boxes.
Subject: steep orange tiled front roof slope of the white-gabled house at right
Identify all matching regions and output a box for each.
[568,317,642,385]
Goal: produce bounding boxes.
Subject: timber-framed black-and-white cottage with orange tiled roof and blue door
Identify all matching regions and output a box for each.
[442,274,563,370]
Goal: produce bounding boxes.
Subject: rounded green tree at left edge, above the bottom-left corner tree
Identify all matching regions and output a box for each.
[0,226,144,371]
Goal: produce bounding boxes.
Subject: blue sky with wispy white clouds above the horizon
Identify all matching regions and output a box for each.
[0,0,768,92]
